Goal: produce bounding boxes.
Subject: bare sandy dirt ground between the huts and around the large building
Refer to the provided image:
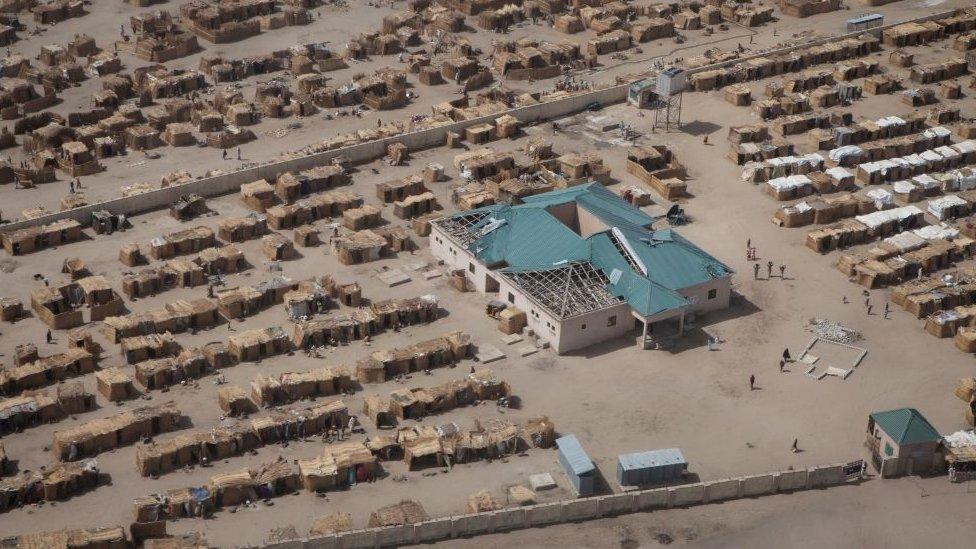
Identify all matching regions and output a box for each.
[0,0,976,547]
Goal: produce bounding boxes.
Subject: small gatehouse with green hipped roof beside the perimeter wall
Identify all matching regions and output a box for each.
[865,408,944,477]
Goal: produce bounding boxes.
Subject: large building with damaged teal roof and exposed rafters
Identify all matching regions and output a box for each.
[430,183,732,353]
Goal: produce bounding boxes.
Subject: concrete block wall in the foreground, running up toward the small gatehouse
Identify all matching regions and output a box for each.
[296,464,853,549]
